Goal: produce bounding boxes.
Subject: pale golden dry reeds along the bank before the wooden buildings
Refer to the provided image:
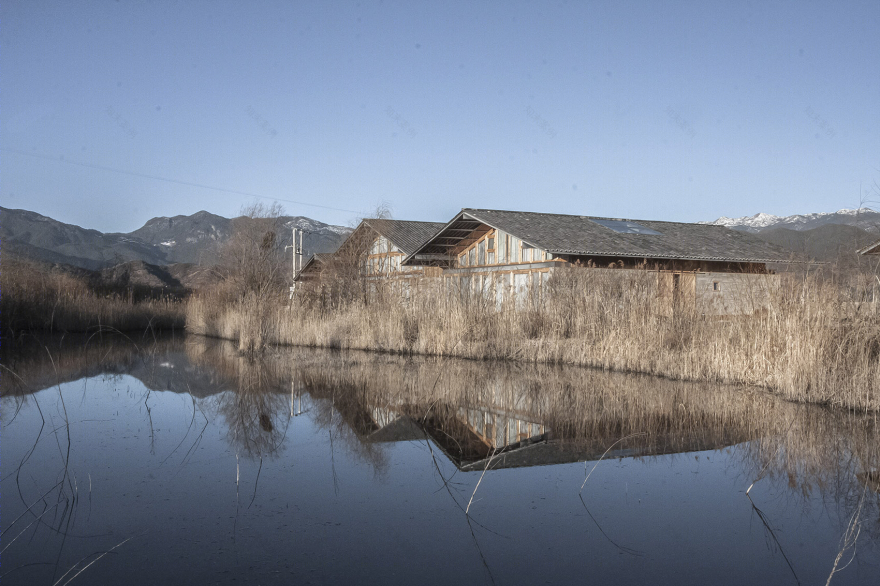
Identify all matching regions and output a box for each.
[187,269,880,410]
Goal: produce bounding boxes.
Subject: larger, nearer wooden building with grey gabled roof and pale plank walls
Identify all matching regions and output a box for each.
[402,208,792,314]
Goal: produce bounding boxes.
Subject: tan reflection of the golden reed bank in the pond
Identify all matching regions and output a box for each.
[187,338,880,494]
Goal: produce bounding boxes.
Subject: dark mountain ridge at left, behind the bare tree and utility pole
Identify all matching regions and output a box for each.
[0,207,351,270]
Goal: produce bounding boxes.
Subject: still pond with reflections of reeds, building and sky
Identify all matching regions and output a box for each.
[0,335,880,585]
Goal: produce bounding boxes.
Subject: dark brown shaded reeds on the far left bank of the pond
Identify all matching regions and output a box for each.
[0,258,185,335]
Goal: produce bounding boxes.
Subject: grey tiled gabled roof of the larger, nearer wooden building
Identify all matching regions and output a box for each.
[404,208,793,264]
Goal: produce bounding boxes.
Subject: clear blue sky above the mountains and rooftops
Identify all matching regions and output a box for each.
[0,0,880,232]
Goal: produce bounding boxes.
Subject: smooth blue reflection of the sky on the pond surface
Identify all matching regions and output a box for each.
[0,376,878,584]
